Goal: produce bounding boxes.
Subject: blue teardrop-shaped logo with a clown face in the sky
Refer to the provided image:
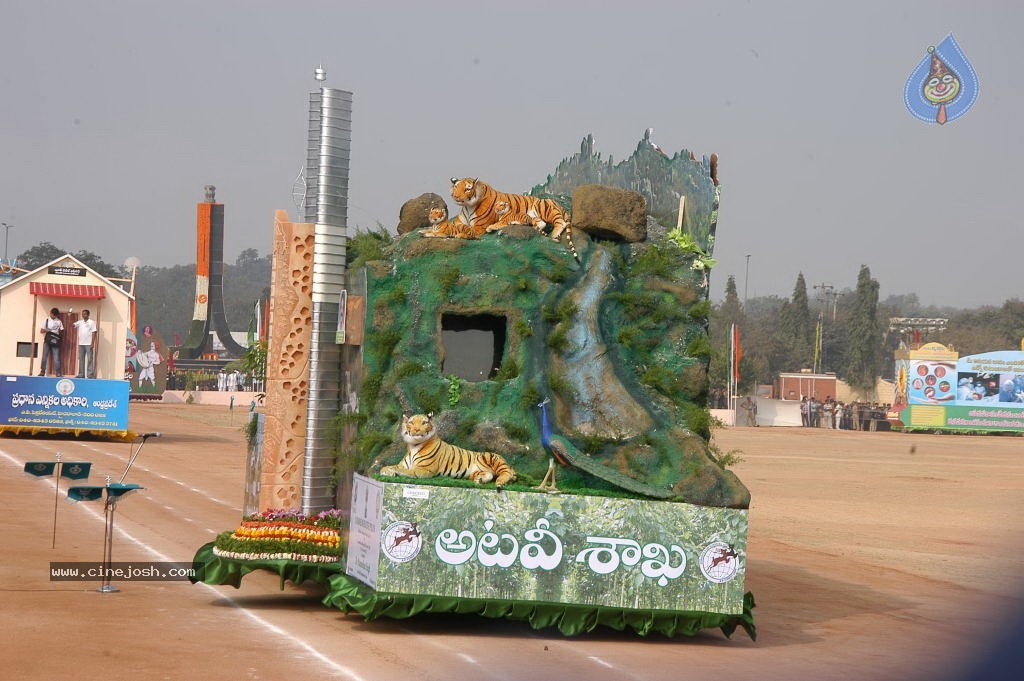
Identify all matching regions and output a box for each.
[903,33,978,125]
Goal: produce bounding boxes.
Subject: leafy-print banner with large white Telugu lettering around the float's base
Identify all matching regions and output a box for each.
[346,475,748,614]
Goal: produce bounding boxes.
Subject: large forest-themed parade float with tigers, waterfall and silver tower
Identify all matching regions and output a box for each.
[196,70,755,637]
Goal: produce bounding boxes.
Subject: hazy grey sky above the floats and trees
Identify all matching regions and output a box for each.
[0,0,1024,306]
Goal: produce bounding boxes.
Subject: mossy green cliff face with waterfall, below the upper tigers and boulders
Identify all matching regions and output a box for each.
[344,201,749,507]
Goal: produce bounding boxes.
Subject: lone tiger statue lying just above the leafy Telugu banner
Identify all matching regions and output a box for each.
[380,414,516,487]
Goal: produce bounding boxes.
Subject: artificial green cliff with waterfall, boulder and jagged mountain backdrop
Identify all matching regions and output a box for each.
[339,131,750,508]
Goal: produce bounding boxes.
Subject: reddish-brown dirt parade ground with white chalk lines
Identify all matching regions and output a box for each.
[0,405,1024,681]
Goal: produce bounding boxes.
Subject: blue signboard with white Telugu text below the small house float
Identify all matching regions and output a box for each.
[0,376,129,430]
